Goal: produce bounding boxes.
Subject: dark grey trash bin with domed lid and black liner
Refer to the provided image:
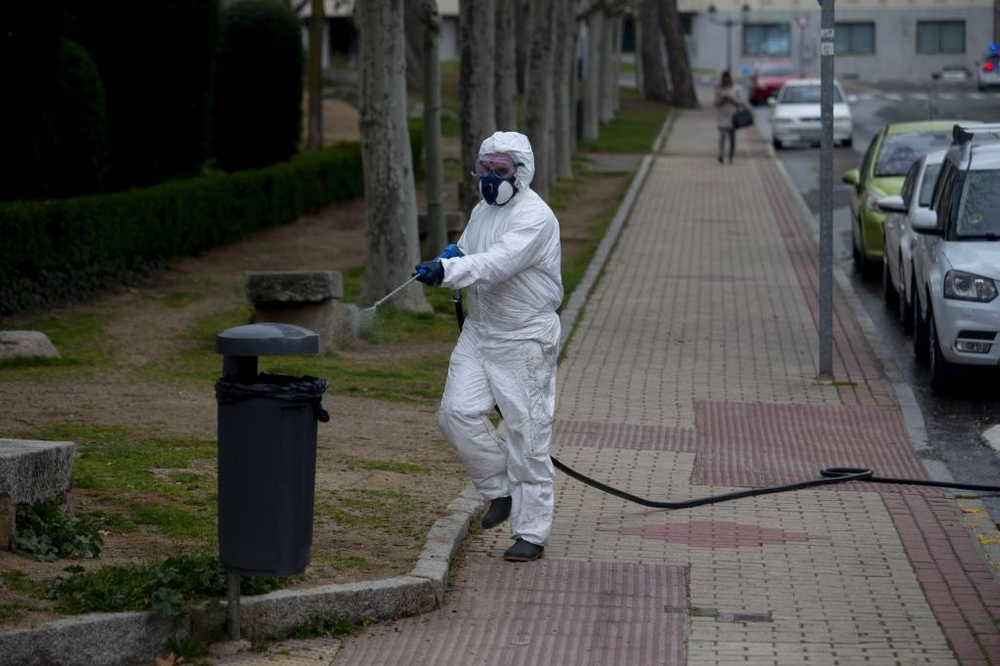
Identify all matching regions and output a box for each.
[215,324,329,576]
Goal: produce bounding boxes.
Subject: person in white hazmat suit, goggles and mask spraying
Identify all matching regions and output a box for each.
[416,132,563,562]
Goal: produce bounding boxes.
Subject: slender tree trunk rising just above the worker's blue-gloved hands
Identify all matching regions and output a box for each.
[420,0,448,253]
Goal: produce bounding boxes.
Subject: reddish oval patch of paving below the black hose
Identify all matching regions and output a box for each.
[612,521,813,548]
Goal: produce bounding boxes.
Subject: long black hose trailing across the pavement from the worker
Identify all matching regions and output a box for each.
[452,289,1000,509]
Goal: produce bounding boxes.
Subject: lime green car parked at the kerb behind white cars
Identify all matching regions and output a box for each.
[842,120,979,278]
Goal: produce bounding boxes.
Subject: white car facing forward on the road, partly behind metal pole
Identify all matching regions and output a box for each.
[769,78,854,149]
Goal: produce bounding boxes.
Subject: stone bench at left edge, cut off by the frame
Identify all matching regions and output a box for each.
[0,438,76,550]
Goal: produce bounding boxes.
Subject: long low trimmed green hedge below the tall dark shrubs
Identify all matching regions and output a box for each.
[0,141,366,314]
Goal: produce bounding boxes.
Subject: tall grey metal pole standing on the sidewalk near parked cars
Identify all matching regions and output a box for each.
[819,0,834,379]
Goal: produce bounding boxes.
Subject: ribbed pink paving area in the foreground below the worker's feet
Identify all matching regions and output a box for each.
[332,558,687,666]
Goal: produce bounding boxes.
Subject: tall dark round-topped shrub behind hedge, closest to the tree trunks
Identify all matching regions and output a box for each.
[211,0,303,171]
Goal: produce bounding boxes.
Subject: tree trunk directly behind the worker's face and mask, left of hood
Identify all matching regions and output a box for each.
[458,0,496,215]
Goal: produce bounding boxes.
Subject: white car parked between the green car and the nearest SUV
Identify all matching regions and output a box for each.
[876,150,945,333]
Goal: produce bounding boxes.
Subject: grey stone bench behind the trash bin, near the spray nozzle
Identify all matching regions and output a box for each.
[243,271,359,349]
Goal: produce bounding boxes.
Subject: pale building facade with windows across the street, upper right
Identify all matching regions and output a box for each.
[679,0,995,82]
